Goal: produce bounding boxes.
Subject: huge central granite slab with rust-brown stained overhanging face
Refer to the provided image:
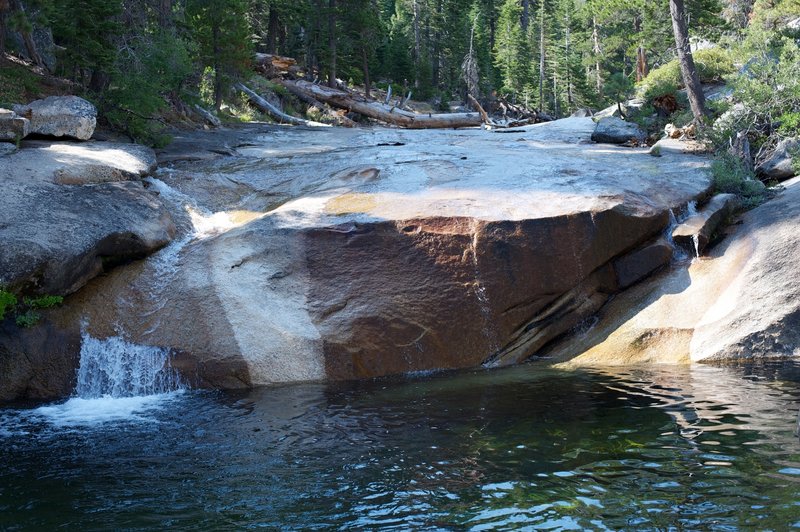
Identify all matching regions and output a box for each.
[42,118,710,394]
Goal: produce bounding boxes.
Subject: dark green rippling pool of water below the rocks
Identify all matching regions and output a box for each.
[0,363,800,530]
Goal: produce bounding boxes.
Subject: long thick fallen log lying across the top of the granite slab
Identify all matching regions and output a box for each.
[283,80,483,129]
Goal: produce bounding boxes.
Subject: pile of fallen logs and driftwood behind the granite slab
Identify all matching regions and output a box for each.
[237,54,550,129]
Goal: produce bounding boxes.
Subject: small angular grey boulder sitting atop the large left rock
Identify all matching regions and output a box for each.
[14,96,97,140]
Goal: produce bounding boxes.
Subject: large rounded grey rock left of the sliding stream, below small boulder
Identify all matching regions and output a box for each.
[0,142,175,295]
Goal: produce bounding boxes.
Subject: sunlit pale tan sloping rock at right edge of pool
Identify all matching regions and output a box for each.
[543,179,800,366]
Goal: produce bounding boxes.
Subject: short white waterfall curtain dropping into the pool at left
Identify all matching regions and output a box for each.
[75,333,183,399]
